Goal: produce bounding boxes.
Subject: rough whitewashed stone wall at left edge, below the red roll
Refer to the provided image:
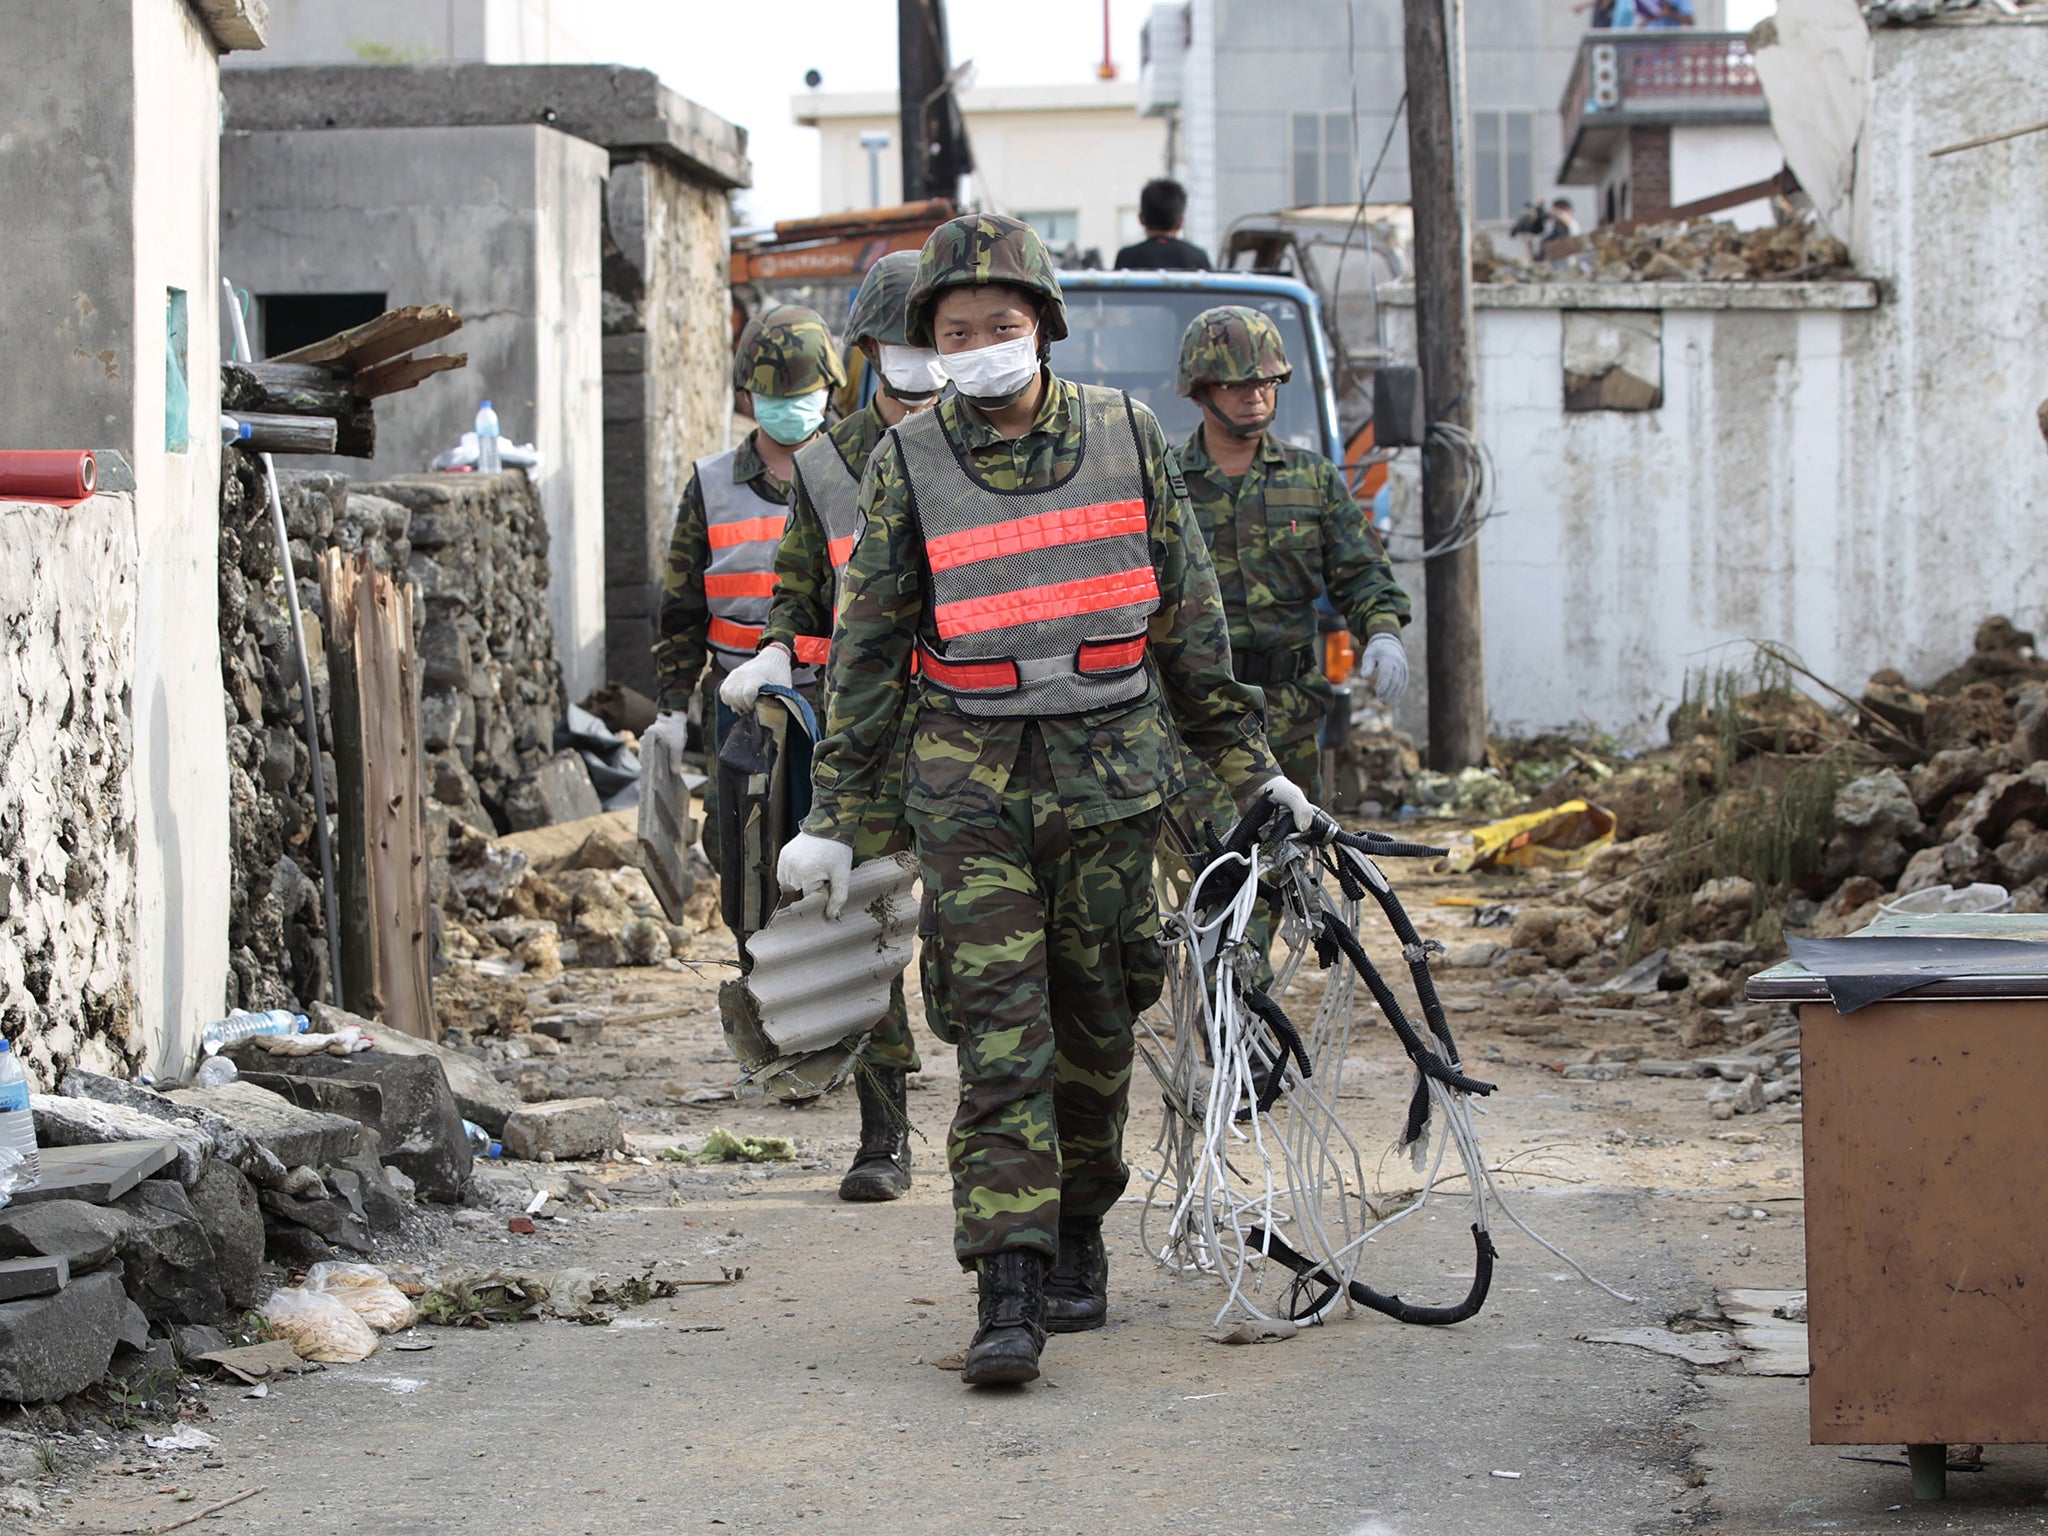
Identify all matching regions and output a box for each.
[0,494,150,1087]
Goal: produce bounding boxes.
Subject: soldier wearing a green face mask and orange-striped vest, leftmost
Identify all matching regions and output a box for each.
[643,305,846,884]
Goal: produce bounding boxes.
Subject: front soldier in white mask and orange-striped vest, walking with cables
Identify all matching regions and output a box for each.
[782,215,1311,1384]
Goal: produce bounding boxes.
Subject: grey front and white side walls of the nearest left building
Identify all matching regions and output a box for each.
[0,0,227,1063]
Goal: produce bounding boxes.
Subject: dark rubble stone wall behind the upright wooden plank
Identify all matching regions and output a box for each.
[221,451,561,1008]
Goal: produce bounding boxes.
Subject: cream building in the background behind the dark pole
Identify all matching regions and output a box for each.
[791,80,1165,266]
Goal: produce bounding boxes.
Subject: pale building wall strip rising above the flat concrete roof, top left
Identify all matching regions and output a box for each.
[229,0,592,68]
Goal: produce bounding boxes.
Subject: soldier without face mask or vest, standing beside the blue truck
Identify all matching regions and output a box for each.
[1176,305,1409,987]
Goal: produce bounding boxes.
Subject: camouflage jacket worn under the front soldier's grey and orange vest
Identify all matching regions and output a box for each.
[805,373,1278,842]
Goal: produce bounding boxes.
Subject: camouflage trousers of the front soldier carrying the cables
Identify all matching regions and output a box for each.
[907,731,1165,1268]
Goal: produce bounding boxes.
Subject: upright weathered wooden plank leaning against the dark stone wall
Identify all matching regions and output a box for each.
[319,549,438,1040]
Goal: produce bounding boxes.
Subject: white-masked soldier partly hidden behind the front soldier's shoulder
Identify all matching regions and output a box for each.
[719,250,944,1200]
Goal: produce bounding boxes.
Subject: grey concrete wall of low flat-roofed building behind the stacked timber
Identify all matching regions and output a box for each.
[221,127,606,698]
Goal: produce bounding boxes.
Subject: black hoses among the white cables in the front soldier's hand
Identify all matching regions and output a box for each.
[1196,801,1495,1327]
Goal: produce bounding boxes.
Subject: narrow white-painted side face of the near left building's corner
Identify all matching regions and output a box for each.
[129,0,229,1071]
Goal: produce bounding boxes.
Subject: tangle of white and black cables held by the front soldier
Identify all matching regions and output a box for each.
[1139,801,1632,1325]
